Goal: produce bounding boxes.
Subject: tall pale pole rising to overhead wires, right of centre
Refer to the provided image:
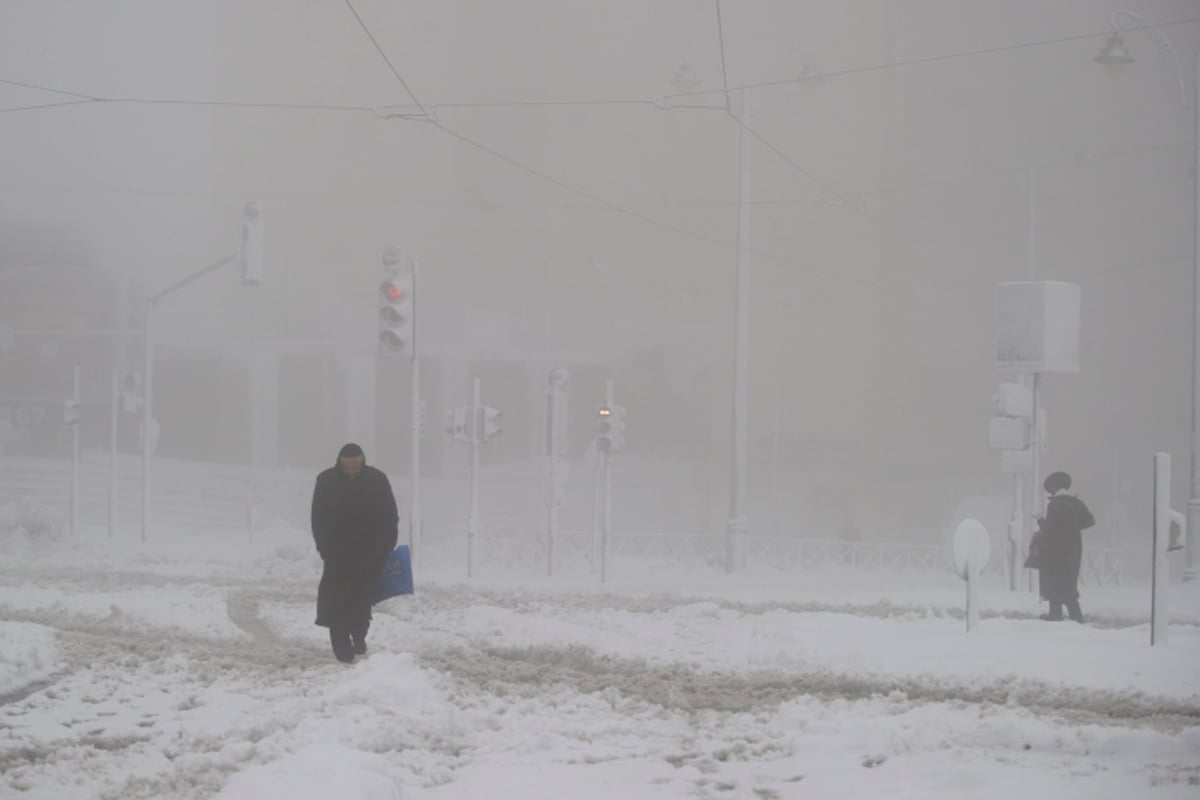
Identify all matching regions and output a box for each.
[725,89,750,572]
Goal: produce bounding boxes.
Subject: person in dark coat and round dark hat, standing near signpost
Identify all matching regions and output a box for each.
[1038,473,1096,622]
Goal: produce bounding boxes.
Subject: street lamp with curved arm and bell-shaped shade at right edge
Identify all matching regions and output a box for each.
[1093,11,1200,581]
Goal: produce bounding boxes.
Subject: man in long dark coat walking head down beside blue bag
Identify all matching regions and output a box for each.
[312,444,400,662]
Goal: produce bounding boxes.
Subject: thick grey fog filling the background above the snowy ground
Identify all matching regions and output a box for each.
[0,0,1200,556]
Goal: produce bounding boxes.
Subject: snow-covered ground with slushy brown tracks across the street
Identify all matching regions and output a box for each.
[0,522,1200,800]
